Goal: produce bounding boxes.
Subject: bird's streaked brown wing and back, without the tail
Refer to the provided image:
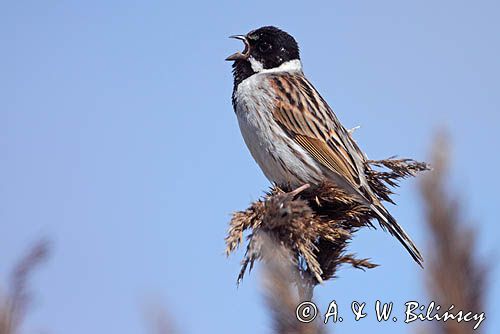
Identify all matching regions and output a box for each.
[269,74,364,190]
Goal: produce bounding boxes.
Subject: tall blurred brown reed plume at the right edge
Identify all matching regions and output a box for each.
[421,135,488,334]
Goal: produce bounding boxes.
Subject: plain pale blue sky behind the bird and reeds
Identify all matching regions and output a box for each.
[0,0,500,333]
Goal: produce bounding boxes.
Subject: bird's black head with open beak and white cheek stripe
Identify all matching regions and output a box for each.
[226,26,300,82]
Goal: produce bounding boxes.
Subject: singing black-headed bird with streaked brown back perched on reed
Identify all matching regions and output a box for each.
[226,26,423,266]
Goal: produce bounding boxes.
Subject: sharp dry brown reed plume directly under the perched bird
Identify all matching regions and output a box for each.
[226,158,428,299]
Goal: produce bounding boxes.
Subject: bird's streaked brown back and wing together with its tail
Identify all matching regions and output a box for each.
[269,73,423,265]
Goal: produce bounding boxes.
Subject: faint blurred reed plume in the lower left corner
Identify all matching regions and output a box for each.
[0,240,49,334]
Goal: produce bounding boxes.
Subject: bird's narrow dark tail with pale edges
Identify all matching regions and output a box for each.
[370,204,424,268]
